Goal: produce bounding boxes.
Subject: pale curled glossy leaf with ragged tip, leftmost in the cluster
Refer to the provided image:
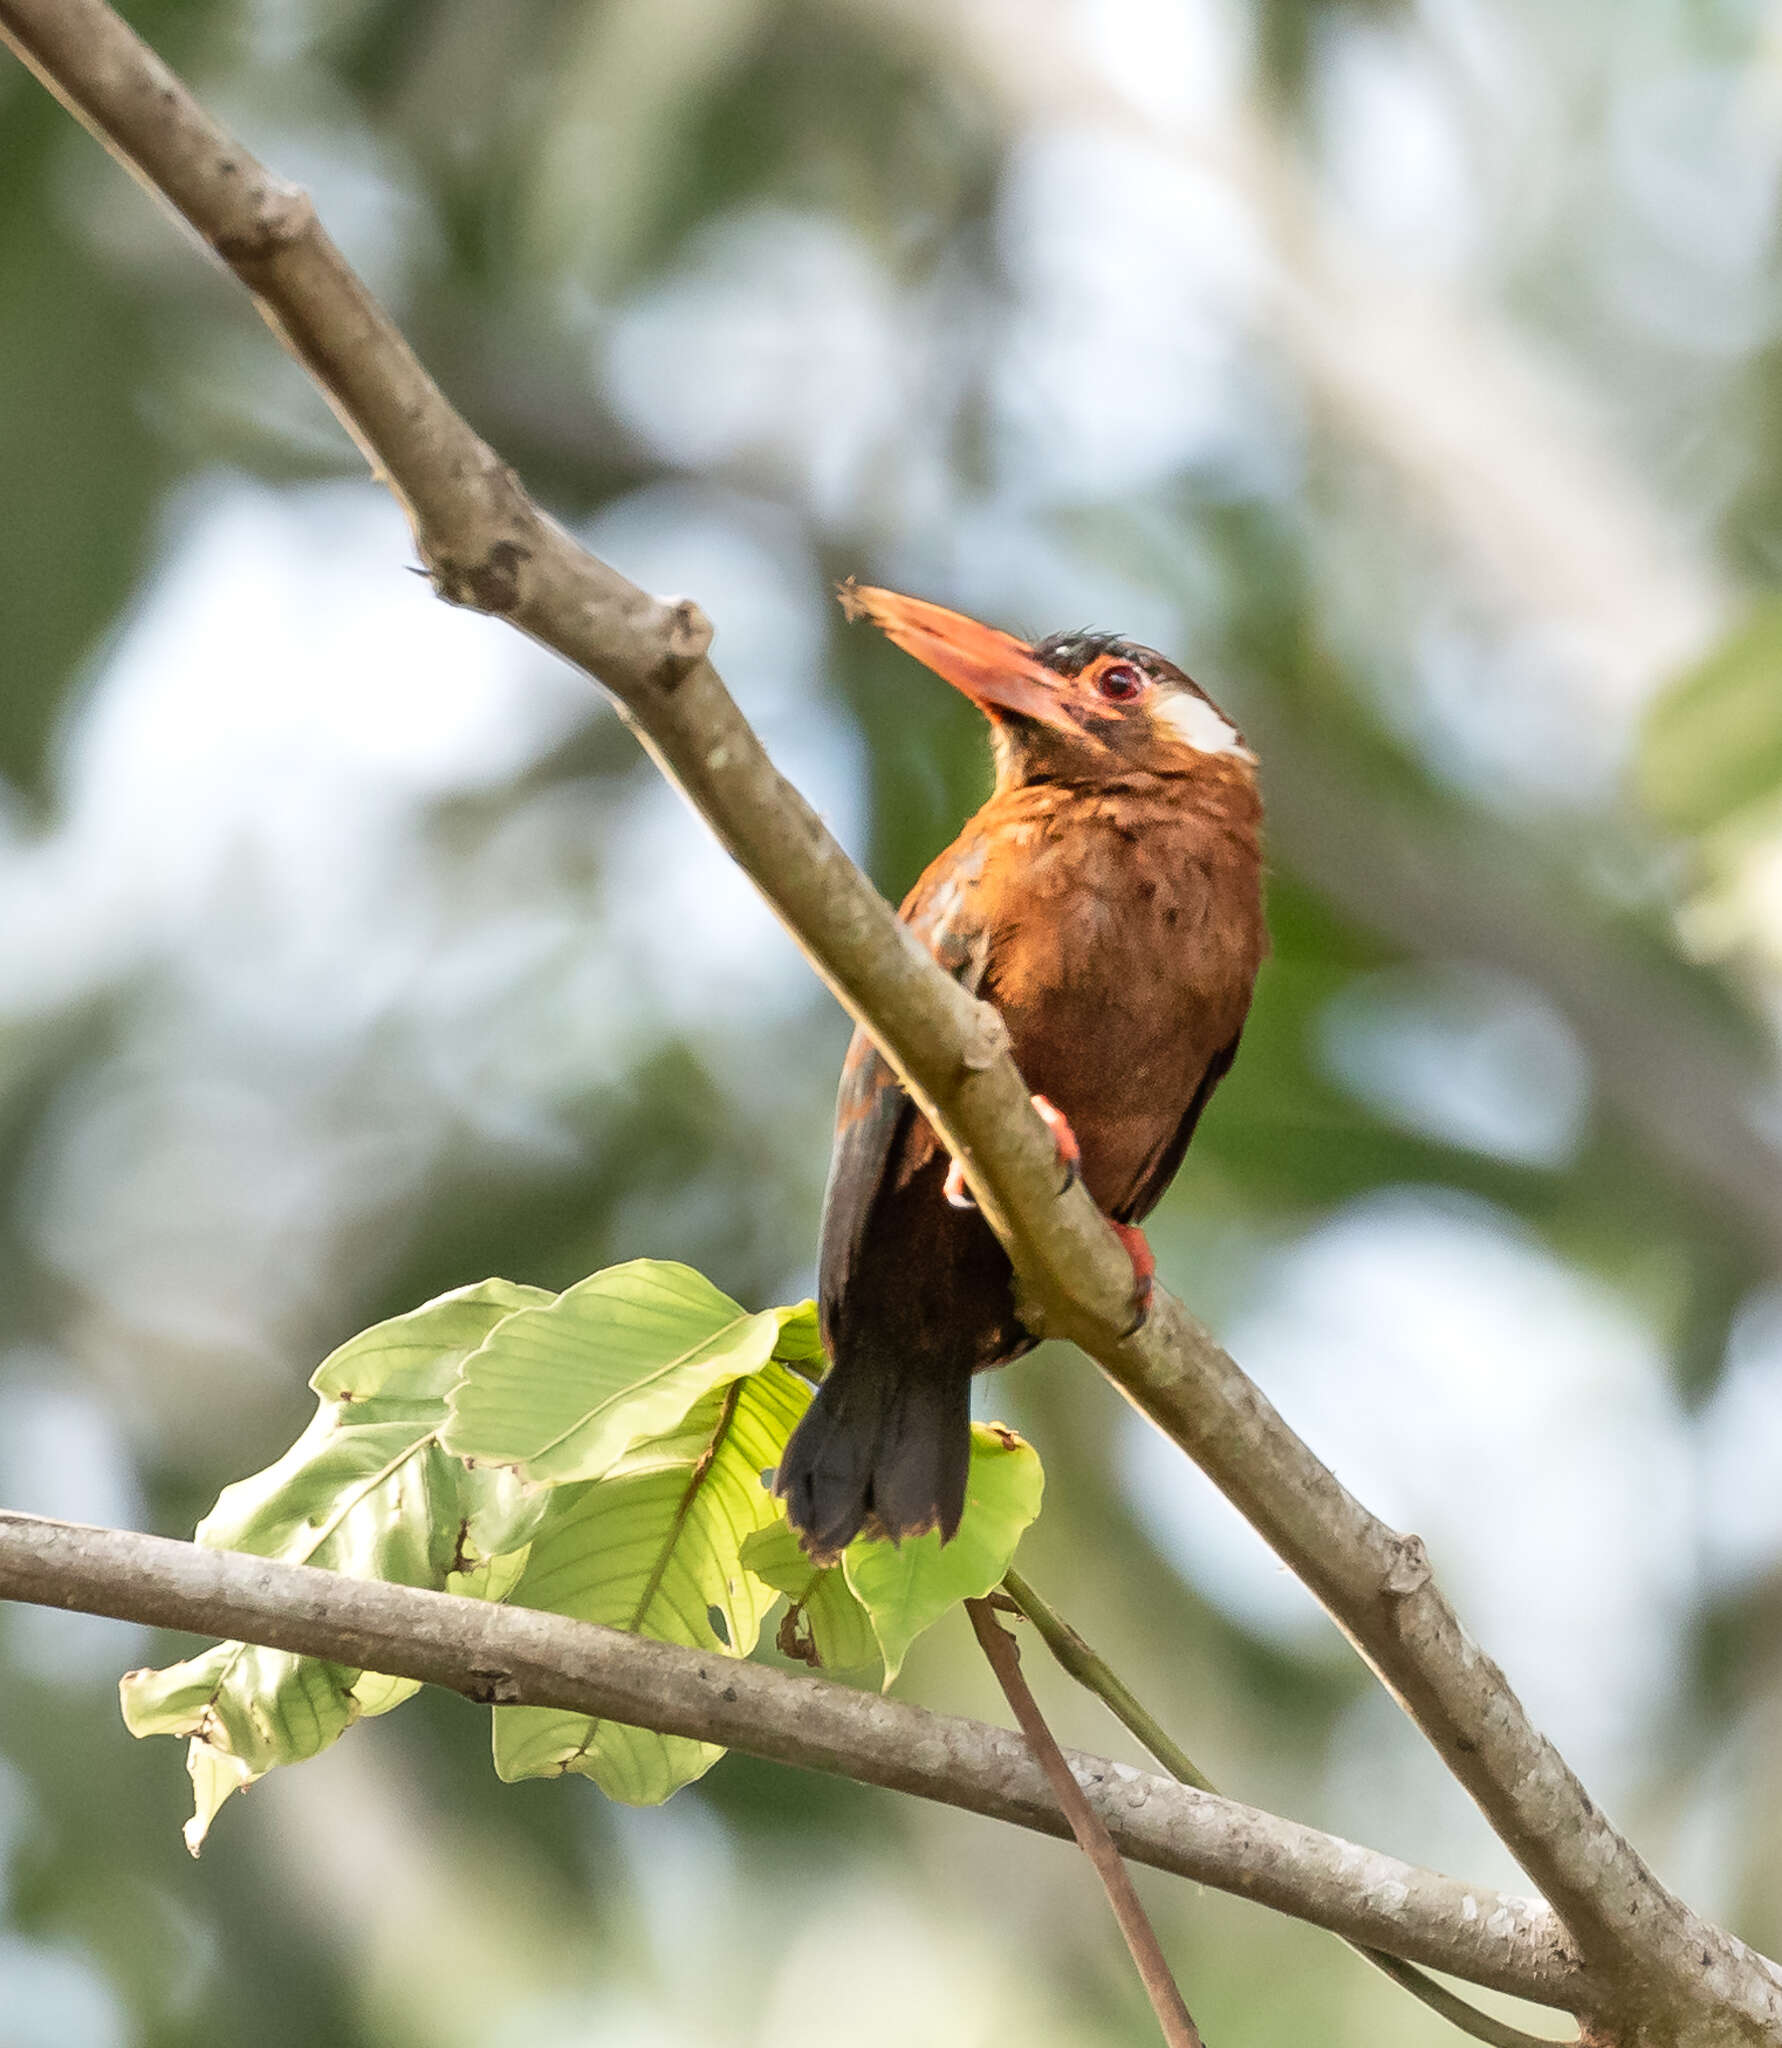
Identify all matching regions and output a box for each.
[119,1280,551,1855]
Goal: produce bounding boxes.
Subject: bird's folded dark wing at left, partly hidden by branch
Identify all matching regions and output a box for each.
[817,838,989,1348]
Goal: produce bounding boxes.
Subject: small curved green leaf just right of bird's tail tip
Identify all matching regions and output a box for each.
[842,1421,1045,1686]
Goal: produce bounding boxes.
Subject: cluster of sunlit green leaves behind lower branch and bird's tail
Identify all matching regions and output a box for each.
[121,1260,1043,1855]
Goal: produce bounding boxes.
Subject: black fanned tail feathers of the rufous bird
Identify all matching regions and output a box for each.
[774,1360,971,1561]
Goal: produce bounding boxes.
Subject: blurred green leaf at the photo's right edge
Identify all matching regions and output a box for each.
[1639,598,1782,834]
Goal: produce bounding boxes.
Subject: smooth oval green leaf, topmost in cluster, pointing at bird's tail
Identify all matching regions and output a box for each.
[444,1260,813,1485]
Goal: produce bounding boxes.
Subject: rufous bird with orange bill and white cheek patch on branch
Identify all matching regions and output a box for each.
[774,582,1268,1563]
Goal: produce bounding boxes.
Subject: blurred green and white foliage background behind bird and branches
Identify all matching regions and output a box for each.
[0,0,1782,2048]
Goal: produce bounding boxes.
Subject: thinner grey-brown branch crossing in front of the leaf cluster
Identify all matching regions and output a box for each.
[0,1509,1587,2007]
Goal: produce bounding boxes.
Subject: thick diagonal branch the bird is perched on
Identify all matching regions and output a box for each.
[0,0,1782,2042]
